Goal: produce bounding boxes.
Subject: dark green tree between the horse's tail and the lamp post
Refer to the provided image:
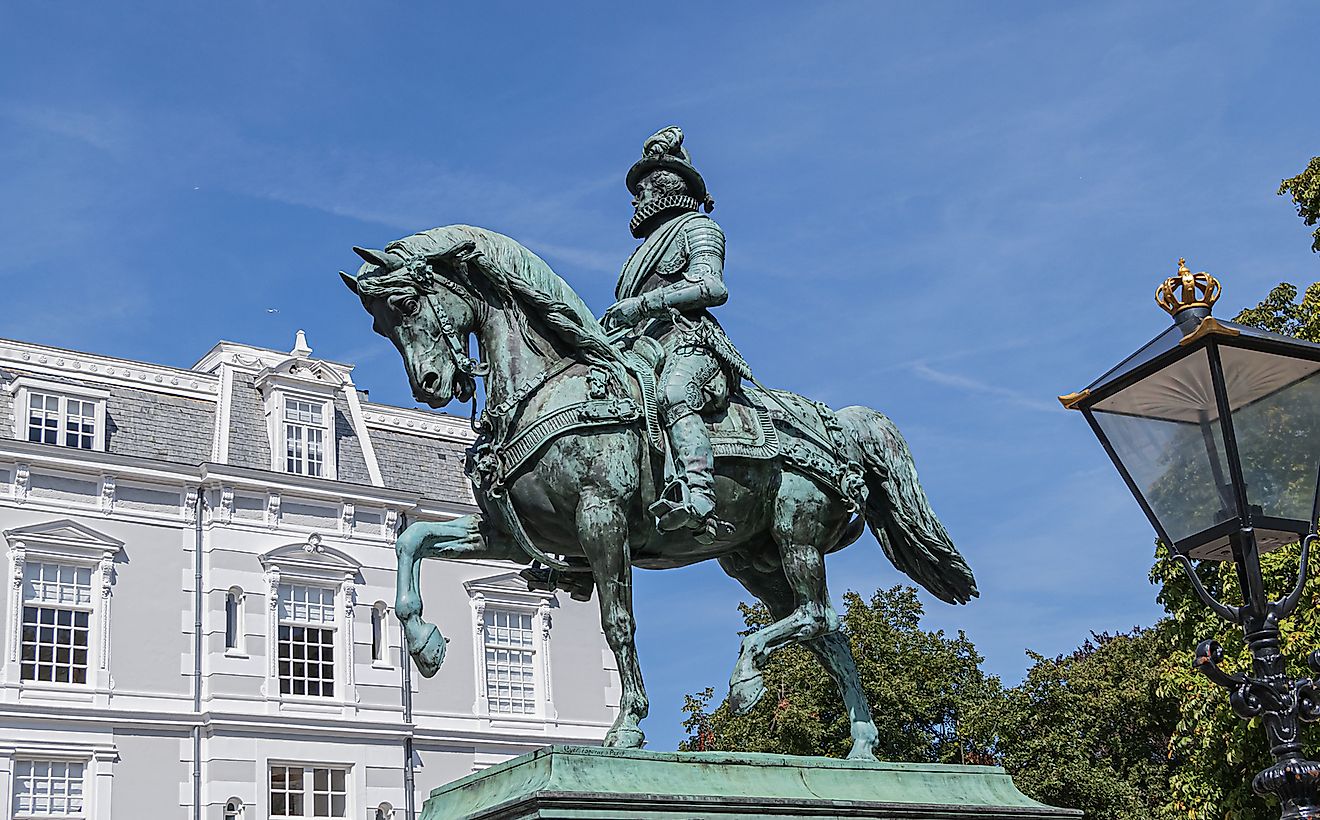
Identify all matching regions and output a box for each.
[994,627,1177,820]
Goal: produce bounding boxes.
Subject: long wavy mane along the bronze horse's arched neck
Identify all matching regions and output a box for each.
[358,224,619,363]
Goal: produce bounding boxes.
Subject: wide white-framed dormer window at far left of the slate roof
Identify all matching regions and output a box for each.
[9,376,110,450]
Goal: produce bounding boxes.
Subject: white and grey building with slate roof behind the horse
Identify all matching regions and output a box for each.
[0,333,619,820]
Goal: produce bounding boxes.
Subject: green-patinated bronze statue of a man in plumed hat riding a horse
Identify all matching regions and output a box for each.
[341,125,977,759]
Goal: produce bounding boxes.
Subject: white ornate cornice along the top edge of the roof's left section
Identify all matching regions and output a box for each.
[0,339,219,401]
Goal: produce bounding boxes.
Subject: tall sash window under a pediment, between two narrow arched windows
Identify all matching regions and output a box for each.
[279,584,335,697]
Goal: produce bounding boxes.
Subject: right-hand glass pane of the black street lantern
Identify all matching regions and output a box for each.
[1220,346,1320,526]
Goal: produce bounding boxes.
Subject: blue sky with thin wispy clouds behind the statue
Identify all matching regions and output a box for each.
[0,1,1320,749]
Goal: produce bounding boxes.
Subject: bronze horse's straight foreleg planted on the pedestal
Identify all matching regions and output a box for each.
[577,491,649,749]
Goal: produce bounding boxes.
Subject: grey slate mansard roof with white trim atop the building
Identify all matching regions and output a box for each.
[0,331,475,506]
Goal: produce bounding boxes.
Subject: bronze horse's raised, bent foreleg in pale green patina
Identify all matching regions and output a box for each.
[395,515,510,677]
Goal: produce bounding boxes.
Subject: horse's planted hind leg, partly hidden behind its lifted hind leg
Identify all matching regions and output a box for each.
[719,544,879,761]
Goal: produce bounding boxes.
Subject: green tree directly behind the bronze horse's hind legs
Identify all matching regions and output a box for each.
[681,586,1001,763]
